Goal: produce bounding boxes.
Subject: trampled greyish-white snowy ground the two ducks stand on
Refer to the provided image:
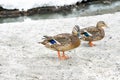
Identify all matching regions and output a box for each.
[0,12,120,80]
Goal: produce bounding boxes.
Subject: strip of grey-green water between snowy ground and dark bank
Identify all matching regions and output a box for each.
[0,1,120,23]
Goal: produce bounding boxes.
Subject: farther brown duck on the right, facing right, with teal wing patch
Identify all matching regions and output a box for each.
[80,21,107,47]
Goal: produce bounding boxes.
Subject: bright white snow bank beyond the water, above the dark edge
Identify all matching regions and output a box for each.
[0,0,82,10]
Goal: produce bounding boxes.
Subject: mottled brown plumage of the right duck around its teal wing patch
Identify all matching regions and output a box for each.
[80,21,106,41]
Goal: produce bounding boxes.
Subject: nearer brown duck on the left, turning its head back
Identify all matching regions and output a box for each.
[39,25,81,60]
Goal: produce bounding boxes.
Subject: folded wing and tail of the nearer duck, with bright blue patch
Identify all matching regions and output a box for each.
[40,33,71,46]
